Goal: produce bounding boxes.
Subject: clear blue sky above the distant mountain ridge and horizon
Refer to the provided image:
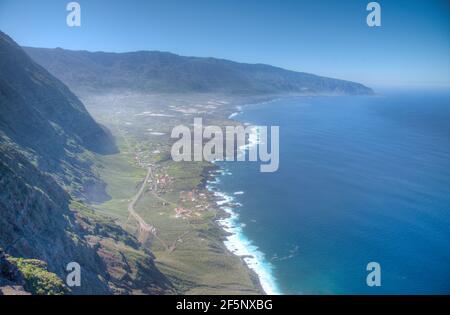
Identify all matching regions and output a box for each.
[0,0,450,86]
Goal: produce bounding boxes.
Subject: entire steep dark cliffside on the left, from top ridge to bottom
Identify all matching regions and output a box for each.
[0,32,171,294]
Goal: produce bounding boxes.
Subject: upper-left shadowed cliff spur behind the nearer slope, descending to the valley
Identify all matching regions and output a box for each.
[0,32,117,201]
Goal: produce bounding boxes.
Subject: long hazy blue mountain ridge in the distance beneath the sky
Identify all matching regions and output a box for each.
[24,47,373,95]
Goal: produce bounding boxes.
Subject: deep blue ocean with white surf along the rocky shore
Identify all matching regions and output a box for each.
[210,91,450,294]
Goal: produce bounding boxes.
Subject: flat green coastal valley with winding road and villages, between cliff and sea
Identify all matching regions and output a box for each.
[81,94,262,294]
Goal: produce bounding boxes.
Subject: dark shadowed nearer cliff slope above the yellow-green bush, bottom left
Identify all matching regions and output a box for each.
[0,144,108,293]
